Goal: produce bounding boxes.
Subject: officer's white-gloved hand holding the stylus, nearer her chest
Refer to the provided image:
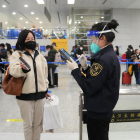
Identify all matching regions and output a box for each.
[77,54,88,70]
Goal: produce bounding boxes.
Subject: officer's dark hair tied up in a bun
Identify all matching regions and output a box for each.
[90,19,119,43]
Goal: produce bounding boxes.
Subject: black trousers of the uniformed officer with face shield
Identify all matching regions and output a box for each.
[87,118,111,140]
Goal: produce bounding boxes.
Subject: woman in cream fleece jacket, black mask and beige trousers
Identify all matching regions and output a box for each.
[10,30,51,140]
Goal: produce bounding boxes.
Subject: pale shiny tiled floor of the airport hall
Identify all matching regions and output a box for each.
[0,65,140,140]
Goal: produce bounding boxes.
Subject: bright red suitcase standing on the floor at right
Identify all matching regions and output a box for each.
[122,71,131,85]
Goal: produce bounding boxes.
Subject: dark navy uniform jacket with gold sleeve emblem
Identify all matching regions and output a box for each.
[72,45,120,118]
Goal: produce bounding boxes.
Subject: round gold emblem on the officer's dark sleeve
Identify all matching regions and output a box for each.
[90,63,103,76]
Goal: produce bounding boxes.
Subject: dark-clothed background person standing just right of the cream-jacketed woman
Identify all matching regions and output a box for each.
[46,45,57,88]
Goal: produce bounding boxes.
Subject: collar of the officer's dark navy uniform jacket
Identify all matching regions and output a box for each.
[91,44,114,60]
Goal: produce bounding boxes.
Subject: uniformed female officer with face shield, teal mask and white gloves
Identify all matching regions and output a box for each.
[67,20,120,140]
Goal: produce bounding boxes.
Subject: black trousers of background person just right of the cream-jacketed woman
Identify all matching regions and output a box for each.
[48,68,55,86]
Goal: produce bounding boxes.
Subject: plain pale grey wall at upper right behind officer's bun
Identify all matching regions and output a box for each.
[112,9,140,53]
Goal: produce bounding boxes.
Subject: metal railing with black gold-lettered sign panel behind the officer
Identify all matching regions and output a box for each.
[79,91,140,140]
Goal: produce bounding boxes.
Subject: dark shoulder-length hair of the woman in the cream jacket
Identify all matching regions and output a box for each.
[15,30,36,51]
